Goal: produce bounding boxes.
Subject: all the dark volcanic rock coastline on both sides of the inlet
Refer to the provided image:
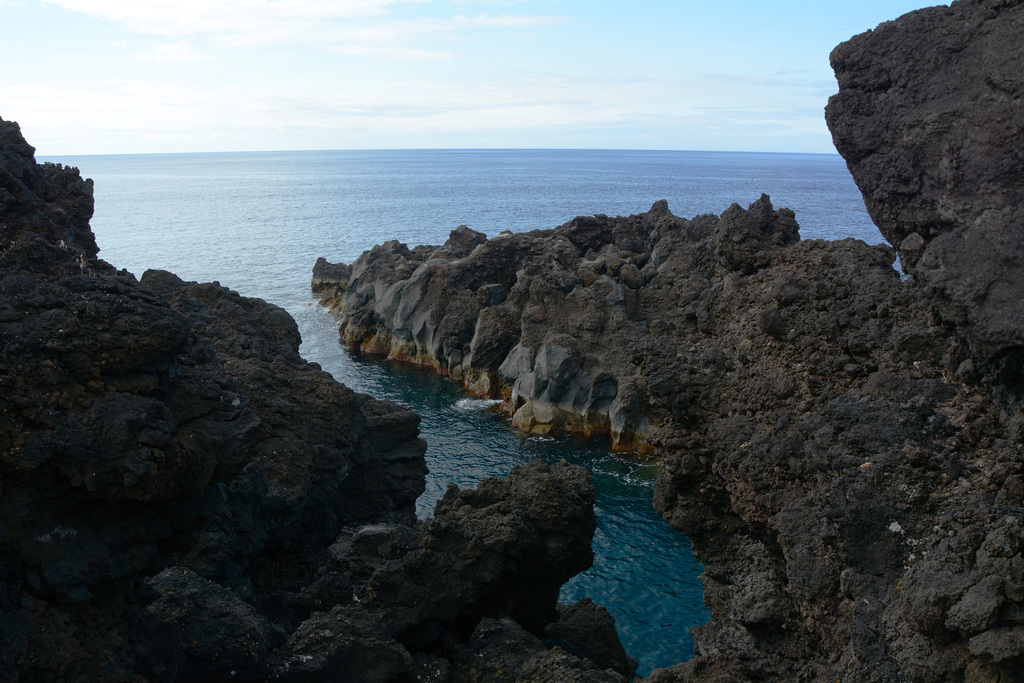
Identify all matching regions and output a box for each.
[0,0,1024,683]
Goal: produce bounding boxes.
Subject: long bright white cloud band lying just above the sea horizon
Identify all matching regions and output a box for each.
[6,72,737,154]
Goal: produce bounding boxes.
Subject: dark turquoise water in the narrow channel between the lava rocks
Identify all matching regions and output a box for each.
[315,358,708,674]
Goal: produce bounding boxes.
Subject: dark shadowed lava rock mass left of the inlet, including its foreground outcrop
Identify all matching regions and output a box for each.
[0,122,630,682]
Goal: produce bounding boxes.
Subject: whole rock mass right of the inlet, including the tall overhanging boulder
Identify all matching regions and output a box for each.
[314,0,1024,682]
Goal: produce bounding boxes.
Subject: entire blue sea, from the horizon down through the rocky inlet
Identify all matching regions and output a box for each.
[46,151,882,674]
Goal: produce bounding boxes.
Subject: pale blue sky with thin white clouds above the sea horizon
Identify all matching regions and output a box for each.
[0,0,948,156]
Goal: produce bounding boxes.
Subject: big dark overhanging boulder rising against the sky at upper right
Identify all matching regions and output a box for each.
[825,0,1024,362]
